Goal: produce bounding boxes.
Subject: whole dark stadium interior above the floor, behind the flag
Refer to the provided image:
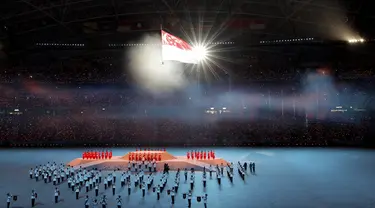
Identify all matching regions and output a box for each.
[0,0,375,147]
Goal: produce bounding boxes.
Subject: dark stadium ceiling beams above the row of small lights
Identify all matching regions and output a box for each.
[0,0,374,42]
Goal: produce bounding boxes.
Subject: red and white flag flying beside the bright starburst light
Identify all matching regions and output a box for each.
[161,30,199,64]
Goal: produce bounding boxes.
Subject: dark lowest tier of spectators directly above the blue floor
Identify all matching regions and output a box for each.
[0,116,367,146]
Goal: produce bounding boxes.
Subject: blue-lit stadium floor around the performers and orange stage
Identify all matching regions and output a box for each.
[0,148,375,208]
